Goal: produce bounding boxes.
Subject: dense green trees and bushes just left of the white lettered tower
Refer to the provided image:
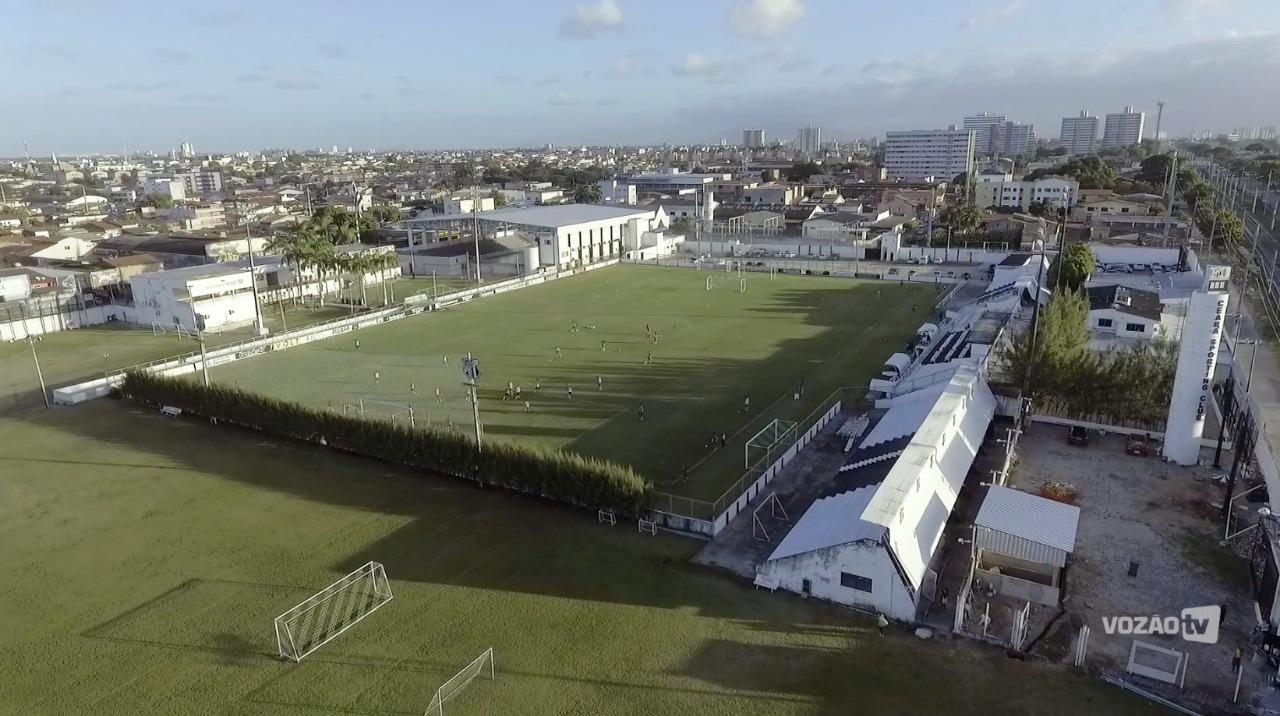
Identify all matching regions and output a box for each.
[1001,289,1178,425]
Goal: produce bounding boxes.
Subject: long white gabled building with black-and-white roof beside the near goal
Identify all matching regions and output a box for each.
[758,366,996,621]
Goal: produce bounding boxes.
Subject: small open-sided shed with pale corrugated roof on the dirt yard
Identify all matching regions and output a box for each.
[973,485,1080,606]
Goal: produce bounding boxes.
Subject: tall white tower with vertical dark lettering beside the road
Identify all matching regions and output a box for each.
[1164,265,1231,465]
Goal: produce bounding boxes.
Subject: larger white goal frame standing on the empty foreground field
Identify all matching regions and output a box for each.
[275,562,392,662]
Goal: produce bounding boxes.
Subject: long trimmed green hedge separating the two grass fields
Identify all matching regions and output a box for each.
[120,371,652,515]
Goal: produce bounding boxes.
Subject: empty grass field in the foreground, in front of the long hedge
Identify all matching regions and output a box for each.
[0,404,1155,716]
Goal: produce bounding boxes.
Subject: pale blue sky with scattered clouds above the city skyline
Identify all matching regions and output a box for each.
[0,0,1280,156]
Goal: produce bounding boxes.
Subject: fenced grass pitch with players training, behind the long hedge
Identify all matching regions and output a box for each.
[214,266,937,500]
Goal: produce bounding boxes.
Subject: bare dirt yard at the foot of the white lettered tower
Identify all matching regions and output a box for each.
[1011,424,1270,711]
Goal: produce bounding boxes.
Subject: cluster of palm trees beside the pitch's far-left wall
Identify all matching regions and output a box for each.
[268,206,399,304]
